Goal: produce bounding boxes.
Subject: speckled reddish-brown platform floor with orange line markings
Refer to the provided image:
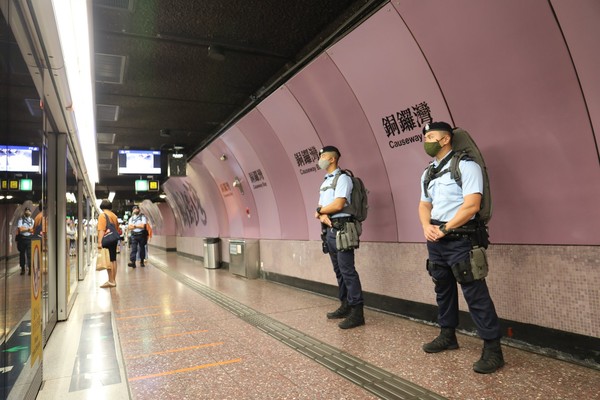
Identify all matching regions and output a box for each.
[38,249,600,400]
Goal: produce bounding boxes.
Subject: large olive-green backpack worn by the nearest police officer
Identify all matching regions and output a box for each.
[423,128,492,226]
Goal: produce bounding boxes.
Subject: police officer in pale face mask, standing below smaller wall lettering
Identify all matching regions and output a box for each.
[315,146,365,329]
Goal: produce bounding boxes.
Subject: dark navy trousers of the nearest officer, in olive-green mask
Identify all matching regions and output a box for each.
[427,238,502,340]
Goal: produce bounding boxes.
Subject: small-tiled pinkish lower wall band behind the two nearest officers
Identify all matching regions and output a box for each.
[260,240,600,337]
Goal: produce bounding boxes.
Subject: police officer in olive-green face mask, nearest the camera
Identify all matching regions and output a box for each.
[419,122,504,374]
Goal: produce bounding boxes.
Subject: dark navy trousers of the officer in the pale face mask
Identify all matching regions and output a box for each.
[326,228,363,306]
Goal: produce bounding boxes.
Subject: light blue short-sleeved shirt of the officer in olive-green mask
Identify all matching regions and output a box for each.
[421,153,483,222]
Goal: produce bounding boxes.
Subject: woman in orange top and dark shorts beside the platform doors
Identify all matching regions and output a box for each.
[98,199,121,289]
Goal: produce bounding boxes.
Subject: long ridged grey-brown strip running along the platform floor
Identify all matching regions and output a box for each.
[152,260,445,400]
